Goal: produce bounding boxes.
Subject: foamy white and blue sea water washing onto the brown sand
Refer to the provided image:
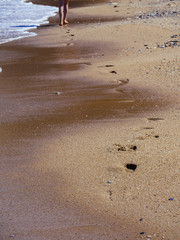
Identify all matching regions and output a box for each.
[0,0,57,44]
